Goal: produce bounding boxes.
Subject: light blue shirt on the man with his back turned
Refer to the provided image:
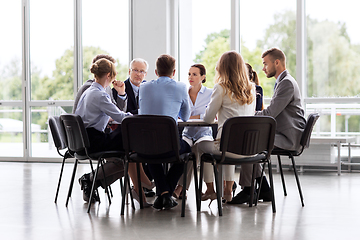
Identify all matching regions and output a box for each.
[139,77,190,122]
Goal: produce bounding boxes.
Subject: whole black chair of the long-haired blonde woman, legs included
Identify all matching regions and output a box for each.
[198,116,276,216]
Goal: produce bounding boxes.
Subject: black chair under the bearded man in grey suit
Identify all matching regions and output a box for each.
[271,113,320,207]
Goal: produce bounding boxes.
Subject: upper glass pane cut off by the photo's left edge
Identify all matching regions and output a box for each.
[0,0,22,101]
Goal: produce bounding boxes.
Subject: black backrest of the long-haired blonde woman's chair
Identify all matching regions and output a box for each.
[220,116,276,156]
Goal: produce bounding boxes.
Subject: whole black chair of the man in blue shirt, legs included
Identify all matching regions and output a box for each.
[121,115,199,217]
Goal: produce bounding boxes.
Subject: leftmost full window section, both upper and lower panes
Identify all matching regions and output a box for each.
[0,0,23,157]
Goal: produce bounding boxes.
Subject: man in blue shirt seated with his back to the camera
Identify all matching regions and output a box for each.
[139,54,191,209]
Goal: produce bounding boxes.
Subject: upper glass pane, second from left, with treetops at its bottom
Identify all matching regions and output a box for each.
[30,0,74,100]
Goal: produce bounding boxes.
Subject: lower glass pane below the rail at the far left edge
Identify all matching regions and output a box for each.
[0,107,24,157]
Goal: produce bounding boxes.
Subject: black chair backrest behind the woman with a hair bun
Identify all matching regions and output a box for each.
[60,114,90,153]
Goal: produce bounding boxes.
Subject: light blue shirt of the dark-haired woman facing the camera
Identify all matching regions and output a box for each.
[183,86,212,142]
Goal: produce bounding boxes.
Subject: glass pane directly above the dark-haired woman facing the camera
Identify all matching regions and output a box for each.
[191,0,231,88]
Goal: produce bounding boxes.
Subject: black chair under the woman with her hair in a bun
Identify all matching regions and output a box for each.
[60,114,131,213]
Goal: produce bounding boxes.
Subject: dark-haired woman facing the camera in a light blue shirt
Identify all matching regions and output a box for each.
[173,64,213,198]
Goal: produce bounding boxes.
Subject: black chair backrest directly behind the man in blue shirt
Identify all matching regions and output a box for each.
[121,115,180,157]
